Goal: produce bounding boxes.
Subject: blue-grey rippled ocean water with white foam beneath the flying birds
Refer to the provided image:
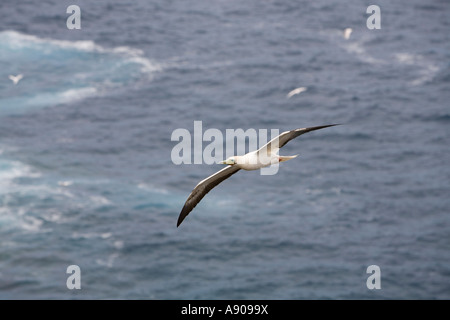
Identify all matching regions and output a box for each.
[0,0,450,299]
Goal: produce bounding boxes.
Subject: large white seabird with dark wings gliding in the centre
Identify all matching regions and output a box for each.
[177,124,338,227]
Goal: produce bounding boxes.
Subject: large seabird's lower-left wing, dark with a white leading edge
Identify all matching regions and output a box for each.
[177,166,240,227]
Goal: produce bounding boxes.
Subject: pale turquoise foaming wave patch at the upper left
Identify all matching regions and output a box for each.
[0,30,162,114]
